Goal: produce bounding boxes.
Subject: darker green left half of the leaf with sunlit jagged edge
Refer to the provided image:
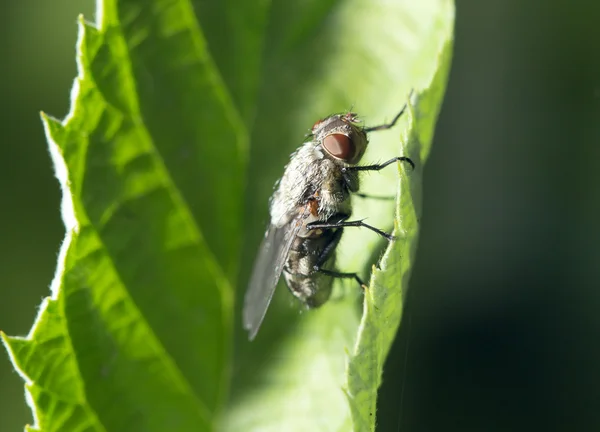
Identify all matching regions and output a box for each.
[4,1,247,431]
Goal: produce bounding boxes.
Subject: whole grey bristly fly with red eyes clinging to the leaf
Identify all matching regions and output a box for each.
[243,95,414,340]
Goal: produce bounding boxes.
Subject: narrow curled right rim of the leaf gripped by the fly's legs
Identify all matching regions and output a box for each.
[347,41,452,431]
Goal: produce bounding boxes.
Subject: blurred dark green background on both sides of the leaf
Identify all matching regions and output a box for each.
[0,0,600,432]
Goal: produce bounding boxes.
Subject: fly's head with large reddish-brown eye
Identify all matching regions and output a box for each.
[312,112,368,165]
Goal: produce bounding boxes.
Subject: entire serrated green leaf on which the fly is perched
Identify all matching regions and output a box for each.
[2,0,453,431]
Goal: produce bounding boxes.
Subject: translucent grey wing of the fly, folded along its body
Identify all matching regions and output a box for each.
[243,206,308,340]
